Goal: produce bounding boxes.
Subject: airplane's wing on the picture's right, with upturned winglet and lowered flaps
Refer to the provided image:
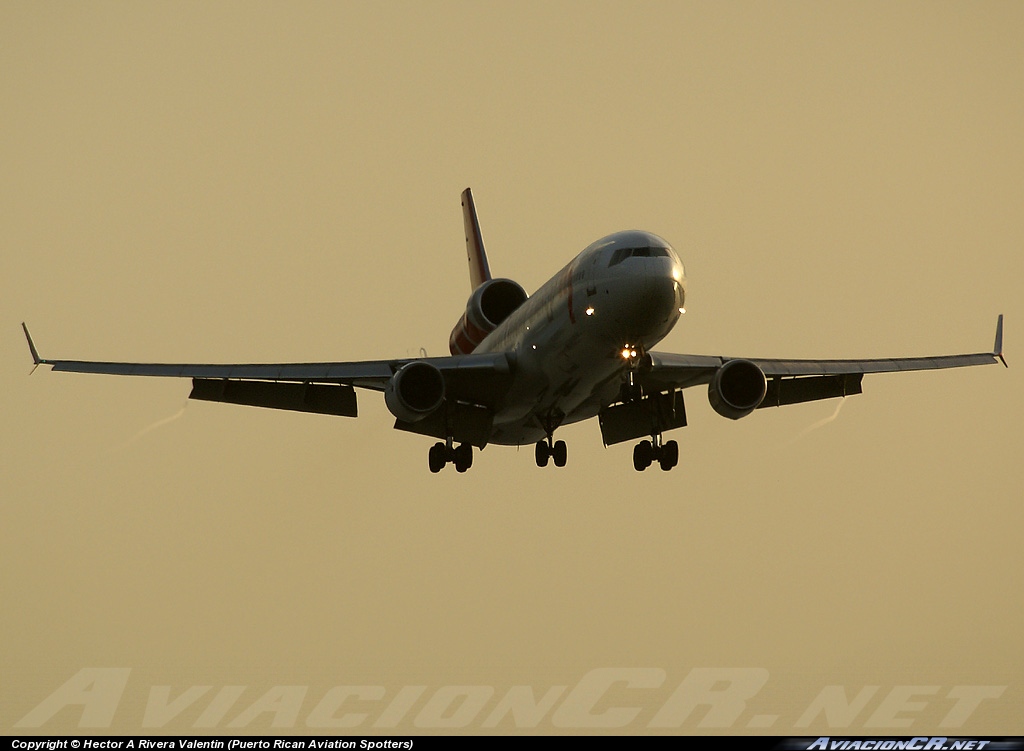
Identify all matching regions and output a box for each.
[641,315,1007,407]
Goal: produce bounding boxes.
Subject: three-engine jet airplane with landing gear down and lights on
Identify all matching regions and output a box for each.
[22,187,1007,472]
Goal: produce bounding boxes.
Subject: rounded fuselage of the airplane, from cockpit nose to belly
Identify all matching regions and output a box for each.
[474,231,686,445]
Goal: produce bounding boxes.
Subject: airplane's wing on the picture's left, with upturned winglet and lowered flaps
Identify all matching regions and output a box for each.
[22,323,511,417]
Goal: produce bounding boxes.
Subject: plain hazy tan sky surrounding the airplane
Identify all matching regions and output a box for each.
[0,1,1024,735]
